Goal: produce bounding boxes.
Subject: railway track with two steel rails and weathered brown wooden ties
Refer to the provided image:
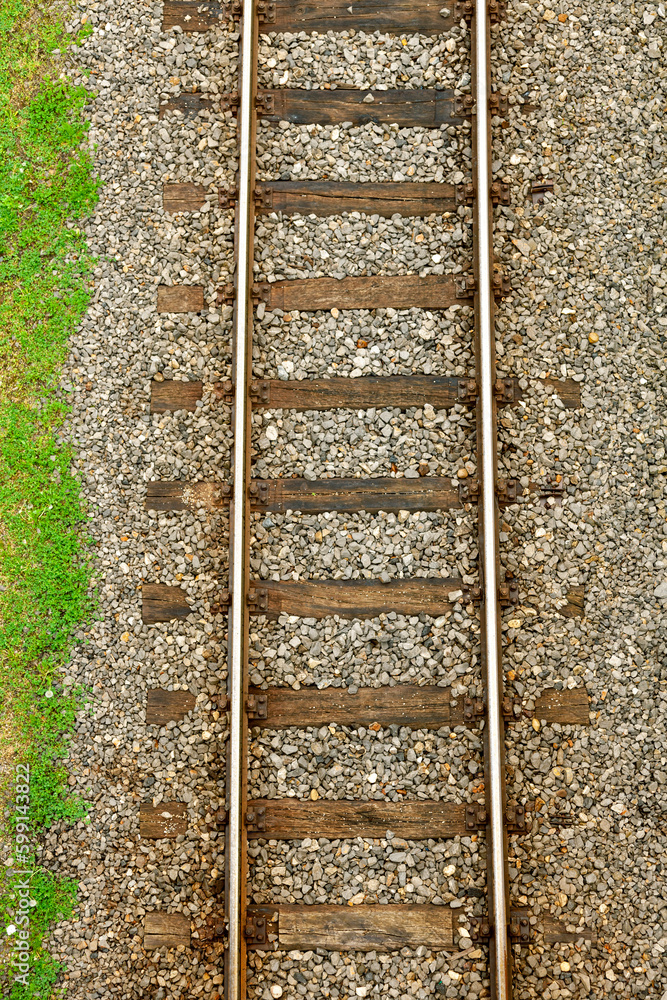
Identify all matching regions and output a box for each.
[141,0,588,1000]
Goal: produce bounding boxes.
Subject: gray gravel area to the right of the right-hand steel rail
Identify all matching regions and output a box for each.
[494,3,667,1000]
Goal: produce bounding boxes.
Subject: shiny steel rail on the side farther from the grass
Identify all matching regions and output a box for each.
[473,0,512,1000]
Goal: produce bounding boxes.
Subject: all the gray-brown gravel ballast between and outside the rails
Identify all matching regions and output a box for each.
[40,0,667,1000]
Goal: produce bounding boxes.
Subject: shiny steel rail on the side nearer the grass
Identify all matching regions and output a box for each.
[225,0,257,1000]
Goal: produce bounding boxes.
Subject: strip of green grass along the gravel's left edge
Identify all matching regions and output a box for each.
[0,0,98,1000]
